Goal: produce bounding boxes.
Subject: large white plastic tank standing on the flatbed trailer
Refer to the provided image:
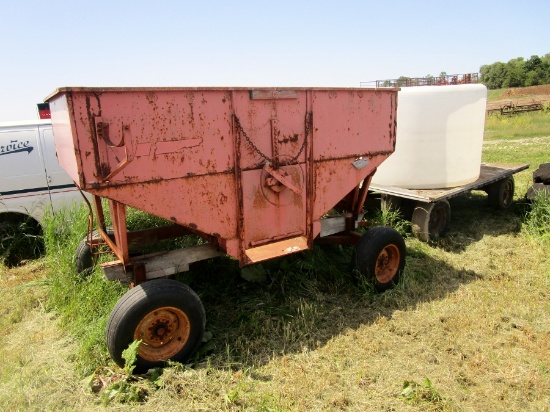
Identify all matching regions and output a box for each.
[372,84,487,189]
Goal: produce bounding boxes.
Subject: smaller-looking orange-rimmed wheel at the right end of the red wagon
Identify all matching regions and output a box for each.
[354,226,406,292]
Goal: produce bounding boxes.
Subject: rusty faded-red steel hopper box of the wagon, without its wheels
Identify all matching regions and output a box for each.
[48,88,397,265]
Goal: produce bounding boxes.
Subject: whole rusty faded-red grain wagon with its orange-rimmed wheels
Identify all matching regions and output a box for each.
[46,88,405,371]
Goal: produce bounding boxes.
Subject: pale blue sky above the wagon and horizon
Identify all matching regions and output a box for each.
[0,0,550,122]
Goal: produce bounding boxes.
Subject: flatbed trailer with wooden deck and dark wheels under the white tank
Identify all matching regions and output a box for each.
[369,163,529,242]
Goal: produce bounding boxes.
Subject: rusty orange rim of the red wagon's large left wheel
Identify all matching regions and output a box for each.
[134,307,191,361]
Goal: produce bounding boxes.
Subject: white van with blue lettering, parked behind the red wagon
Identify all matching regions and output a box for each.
[0,116,83,265]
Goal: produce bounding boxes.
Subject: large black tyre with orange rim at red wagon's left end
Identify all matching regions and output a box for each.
[107,279,206,373]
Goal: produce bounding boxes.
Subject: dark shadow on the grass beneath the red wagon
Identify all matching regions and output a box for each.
[180,240,480,369]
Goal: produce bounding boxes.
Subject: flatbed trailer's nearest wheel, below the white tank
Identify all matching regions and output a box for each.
[411,200,451,242]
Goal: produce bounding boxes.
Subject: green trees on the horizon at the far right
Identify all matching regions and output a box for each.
[480,53,550,89]
